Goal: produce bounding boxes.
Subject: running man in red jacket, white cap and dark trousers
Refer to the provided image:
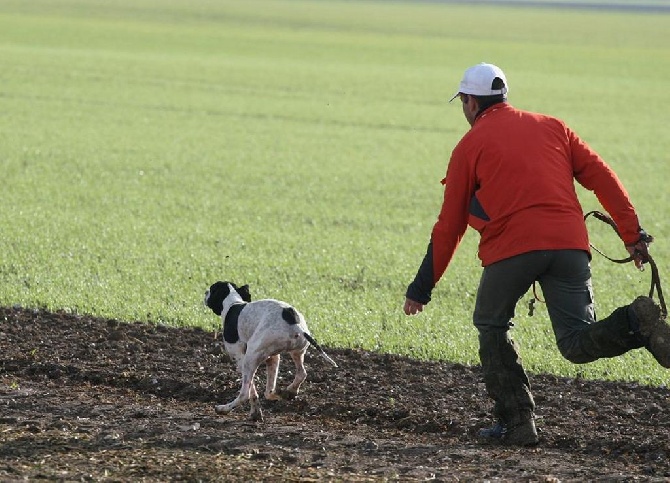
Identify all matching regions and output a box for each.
[404,63,670,446]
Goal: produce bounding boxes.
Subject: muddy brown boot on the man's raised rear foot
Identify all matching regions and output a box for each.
[630,297,670,369]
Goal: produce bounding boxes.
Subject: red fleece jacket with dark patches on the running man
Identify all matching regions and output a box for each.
[408,103,640,302]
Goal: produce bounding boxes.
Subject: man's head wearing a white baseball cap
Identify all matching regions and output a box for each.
[449,62,509,125]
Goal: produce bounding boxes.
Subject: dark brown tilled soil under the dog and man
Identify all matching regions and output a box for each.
[0,309,670,482]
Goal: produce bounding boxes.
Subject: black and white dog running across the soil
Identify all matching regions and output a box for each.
[205,282,337,421]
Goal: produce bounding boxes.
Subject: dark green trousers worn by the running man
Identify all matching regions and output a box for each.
[473,250,644,420]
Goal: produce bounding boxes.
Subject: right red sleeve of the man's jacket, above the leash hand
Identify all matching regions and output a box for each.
[566,128,641,245]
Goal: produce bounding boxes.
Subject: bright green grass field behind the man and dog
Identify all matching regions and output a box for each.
[0,0,670,384]
